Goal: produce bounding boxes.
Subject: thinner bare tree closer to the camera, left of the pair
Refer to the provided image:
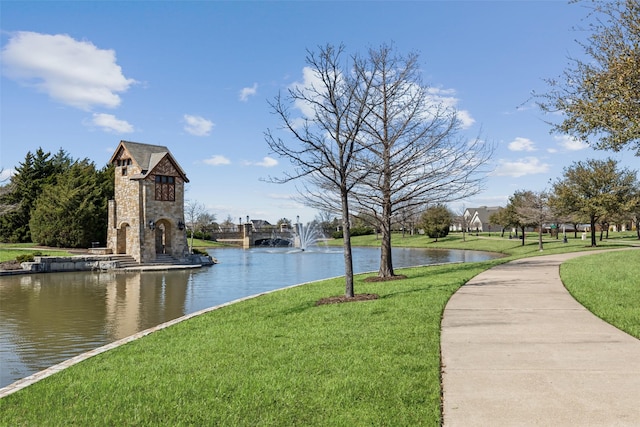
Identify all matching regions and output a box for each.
[265,45,371,298]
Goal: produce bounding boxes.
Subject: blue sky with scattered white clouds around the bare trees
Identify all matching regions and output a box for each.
[0,0,638,223]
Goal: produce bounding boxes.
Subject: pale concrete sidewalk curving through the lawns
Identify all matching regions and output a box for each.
[441,252,640,427]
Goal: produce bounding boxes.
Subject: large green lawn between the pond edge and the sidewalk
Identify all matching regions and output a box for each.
[0,261,500,426]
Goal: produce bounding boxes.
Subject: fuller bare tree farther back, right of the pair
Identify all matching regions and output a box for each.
[352,45,493,278]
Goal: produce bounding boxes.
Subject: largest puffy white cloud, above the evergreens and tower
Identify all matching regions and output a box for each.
[2,31,136,111]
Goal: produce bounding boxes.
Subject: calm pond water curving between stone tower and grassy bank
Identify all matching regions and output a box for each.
[0,248,496,387]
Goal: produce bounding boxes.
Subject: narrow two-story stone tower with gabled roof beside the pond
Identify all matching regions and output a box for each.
[107,141,189,263]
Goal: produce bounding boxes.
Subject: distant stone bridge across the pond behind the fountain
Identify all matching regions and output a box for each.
[211,223,300,249]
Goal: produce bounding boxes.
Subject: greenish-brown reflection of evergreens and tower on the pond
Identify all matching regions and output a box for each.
[0,271,189,386]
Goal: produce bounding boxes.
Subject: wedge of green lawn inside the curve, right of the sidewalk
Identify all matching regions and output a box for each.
[560,250,640,339]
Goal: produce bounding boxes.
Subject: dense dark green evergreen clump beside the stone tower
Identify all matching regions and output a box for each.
[0,148,114,248]
